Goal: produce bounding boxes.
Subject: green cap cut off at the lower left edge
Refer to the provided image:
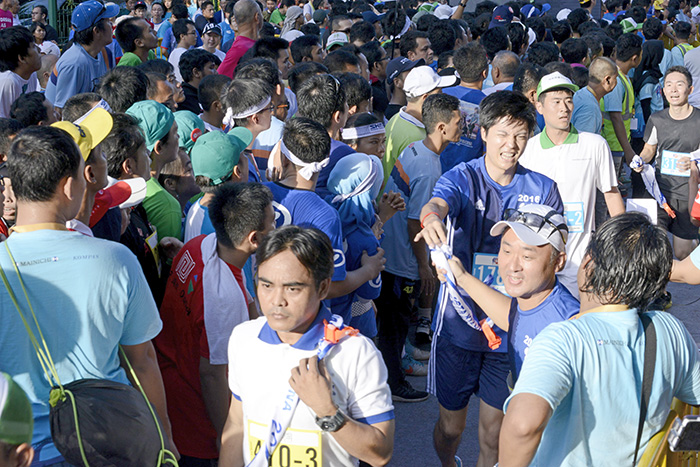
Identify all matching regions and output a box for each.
[0,373,34,444]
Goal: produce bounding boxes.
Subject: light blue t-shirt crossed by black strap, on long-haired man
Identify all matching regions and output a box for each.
[504,309,700,466]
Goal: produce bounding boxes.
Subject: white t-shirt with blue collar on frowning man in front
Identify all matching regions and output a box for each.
[229,306,394,467]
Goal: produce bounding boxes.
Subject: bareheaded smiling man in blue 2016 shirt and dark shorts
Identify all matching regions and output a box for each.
[415,91,563,467]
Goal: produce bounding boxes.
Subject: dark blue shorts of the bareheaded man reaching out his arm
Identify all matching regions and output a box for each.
[431,337,510,410]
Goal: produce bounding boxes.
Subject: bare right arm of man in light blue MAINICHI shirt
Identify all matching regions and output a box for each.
[122,341,180,458]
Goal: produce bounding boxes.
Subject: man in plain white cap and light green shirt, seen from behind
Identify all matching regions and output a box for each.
[383,65,457,181]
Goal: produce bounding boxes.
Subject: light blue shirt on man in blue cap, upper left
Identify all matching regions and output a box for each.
[46,44,109,109]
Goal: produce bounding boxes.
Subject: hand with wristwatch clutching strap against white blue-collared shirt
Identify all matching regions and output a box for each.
[289,356,338,417]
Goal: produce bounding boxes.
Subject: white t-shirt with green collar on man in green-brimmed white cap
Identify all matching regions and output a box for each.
[519,127,617,297]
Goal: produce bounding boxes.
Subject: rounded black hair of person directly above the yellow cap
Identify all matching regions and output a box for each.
[98,66,148,112]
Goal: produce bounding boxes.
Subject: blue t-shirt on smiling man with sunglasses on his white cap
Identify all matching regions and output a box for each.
[508,280,581,381]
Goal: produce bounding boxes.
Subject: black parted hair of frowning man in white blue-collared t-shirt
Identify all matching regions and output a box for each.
[255,225,334,289]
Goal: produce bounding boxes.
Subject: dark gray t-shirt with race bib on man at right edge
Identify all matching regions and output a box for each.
[644,108,700,200]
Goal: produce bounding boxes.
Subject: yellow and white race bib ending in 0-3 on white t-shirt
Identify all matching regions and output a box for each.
[248,420,323,467]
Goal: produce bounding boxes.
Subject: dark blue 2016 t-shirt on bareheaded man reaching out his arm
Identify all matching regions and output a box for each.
[433,157,564,352]
